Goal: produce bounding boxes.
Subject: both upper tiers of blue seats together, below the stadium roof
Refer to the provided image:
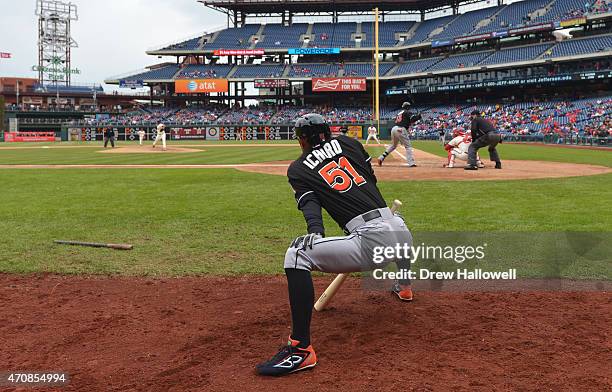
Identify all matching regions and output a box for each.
[107,0,612,99]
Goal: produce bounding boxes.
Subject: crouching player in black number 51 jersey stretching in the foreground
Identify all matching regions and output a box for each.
[256,113,412,376]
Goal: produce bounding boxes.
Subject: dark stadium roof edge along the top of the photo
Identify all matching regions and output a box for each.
[198,0,464,14]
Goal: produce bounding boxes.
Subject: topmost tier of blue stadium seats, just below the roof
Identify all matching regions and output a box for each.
[147,0,612,55]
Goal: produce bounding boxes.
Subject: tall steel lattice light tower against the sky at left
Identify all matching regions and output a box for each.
[36,0,80,86]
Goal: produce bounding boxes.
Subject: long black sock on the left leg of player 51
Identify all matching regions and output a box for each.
[285,268,314,348]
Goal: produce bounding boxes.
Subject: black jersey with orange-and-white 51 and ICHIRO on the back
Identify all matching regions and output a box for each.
[287,135,387,228]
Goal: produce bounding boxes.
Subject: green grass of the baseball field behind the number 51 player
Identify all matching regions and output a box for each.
[0,142,612,279]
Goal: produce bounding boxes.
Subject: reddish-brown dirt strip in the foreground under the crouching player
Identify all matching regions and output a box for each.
[0,275,612,392]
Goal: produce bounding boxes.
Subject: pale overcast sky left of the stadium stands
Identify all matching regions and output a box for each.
[0,0,226,89]
